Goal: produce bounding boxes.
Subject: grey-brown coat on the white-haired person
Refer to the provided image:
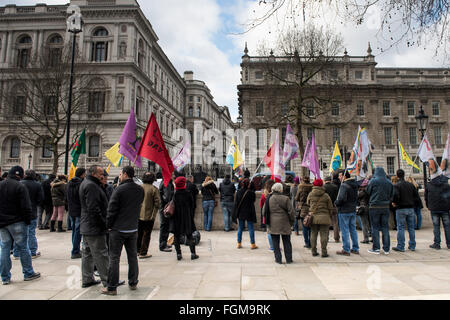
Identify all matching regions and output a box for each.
[263,192,295,235]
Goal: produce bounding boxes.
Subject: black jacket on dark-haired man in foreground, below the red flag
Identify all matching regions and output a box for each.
[106,179,144,231]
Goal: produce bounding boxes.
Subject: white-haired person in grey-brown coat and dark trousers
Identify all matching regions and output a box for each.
[263,183,295,264]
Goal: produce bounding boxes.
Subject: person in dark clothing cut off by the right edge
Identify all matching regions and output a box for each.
[425,174,450,250]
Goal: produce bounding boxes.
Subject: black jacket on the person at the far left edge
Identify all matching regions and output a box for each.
[0,176,32,228]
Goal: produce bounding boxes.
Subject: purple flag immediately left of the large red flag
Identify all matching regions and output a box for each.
[119,108,142,168]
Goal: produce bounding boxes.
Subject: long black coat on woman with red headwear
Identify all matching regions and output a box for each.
[169,190,196,235]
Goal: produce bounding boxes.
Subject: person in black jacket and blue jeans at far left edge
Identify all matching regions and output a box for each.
[0,166,41,285]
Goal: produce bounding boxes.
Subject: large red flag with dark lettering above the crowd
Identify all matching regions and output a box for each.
[137,113,174,187]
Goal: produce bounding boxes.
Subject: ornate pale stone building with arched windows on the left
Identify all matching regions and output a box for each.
[0,0,233,175]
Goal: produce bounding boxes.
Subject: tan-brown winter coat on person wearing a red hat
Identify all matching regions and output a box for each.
[306,187,334,225]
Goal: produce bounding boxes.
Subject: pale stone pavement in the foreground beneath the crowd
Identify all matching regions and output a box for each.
[0,228,450,300]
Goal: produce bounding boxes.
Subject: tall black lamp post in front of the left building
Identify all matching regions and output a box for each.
[64,5,83,175]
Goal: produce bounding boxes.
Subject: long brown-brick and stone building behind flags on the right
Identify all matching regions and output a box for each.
[238,44,450,179]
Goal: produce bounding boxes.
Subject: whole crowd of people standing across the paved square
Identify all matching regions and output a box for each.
[0,165,450,295]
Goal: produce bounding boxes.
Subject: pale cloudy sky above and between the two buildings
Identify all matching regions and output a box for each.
[0,0,448,121]
